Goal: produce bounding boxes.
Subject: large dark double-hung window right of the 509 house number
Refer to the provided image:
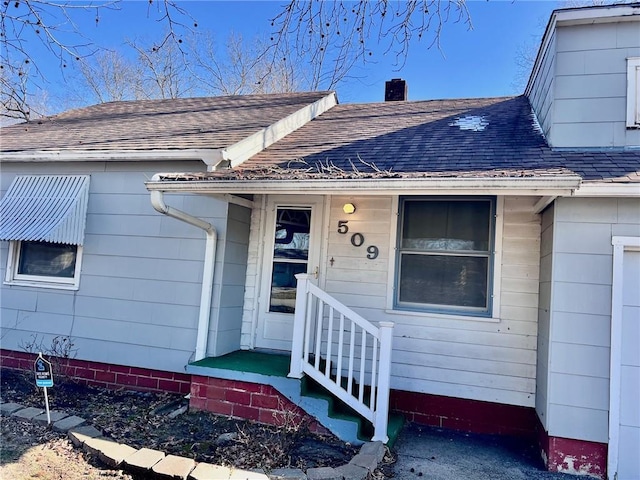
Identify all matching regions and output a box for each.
[395,197,496,316]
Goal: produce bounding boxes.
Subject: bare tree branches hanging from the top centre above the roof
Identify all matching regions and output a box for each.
[271,0,471,88]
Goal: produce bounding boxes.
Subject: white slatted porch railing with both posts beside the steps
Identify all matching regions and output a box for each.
[289,274,394,443]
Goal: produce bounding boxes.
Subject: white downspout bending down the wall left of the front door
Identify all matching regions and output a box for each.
[150,176,218,361]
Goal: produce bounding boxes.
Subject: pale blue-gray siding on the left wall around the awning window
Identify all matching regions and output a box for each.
[0,162,227,372]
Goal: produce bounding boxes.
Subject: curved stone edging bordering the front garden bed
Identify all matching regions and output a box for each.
[0,403,386,480]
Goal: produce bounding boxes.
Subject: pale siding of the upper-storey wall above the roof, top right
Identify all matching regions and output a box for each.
[544,19,640,147]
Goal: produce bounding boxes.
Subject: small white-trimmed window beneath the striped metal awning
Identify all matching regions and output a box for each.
[6,241,82,288]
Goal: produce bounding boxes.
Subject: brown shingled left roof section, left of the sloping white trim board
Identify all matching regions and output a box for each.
[0,92,330,152]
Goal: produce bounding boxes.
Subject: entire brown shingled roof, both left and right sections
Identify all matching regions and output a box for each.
[0,92,640,182]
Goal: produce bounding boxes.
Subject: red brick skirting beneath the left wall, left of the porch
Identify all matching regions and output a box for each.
[0,349,191,394]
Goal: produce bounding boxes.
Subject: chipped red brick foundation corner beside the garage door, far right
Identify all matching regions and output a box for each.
[538,418,608,480]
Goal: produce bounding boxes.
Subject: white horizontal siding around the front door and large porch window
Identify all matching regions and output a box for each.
[242,196,540,407]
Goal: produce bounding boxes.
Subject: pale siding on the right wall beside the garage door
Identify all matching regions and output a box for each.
[536,198,640,443]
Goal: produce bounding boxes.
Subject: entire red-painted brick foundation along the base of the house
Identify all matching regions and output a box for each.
[7,349,596,462]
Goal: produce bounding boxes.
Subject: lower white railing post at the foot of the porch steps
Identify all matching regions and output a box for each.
[371,322,394,443]
